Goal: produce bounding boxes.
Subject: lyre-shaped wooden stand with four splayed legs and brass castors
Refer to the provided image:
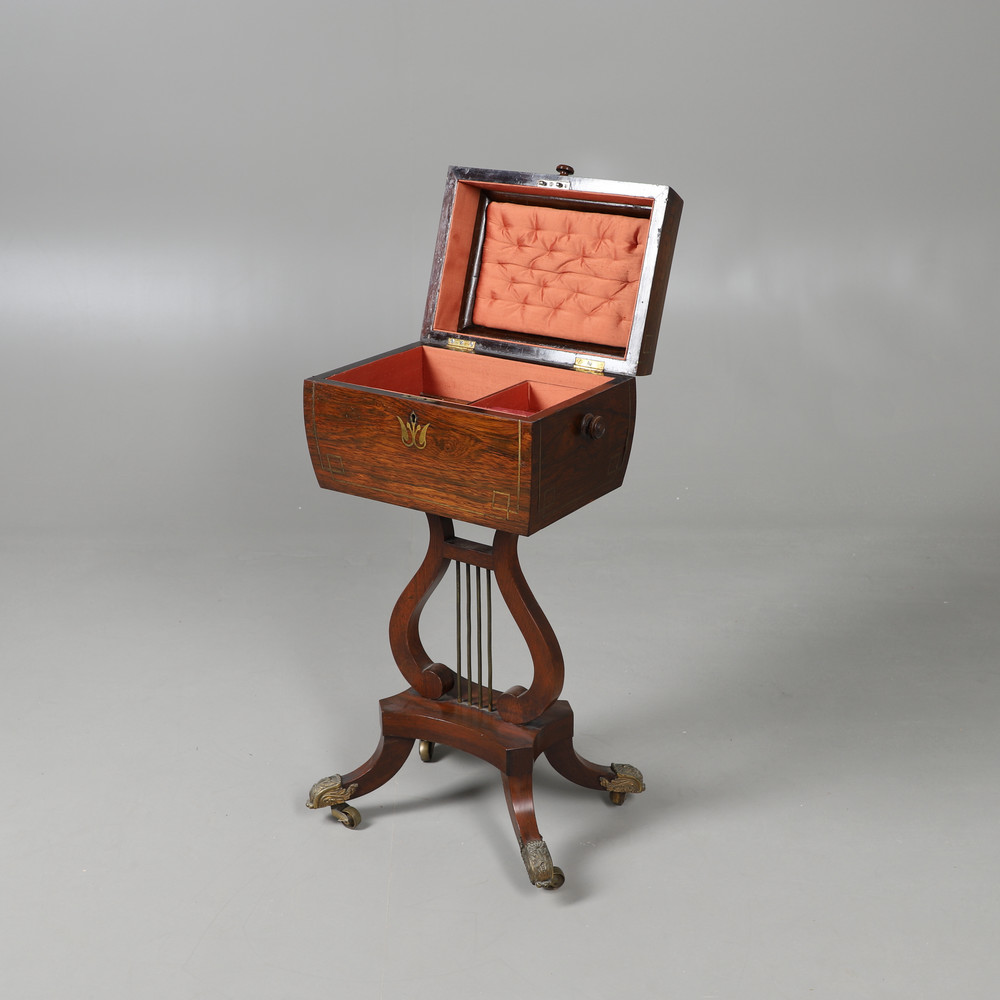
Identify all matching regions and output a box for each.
[307,514,644,889]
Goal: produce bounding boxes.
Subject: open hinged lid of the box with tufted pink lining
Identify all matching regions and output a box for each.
[420,165,682,375]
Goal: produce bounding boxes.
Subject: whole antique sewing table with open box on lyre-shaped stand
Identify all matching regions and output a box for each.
[305,165,682,889]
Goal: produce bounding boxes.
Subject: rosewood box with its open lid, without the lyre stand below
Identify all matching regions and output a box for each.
[305,167,682,535]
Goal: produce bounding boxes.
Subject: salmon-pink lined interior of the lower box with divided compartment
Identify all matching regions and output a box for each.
[329,346,611,416]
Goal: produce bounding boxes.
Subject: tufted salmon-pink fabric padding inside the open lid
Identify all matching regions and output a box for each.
[472,201,649,347]
